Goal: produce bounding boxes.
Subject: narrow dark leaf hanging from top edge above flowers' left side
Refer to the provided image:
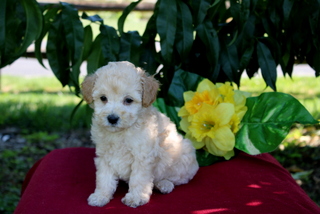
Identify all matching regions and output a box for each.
[176,1,193,60]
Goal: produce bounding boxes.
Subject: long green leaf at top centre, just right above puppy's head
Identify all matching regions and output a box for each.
[156,0,177,64]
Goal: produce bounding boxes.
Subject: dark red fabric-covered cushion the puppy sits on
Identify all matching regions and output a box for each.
[15,148,320,214]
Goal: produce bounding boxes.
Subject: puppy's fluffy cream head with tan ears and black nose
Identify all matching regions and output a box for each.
[82,62,159,132]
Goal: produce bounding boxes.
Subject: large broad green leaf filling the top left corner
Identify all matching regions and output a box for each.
[0,0,42,68]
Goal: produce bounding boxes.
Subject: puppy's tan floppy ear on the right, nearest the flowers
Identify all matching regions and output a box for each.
[142,72,159,107]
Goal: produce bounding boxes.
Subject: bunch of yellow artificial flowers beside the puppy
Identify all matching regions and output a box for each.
[178,79,249,160]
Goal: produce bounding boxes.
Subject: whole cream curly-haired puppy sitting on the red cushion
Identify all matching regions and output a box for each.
[82,62,199,207]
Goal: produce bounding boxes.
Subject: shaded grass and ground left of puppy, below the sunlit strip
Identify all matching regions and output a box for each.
[0,98,92,213]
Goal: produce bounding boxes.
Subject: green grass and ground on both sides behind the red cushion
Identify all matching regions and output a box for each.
[0,76,320,213]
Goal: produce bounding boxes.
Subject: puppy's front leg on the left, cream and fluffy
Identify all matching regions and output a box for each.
[88,157,118,207]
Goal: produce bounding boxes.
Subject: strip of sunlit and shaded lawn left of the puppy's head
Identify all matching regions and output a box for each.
[0,76,90,132]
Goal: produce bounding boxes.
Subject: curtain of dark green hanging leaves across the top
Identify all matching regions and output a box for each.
[0,0,320,99]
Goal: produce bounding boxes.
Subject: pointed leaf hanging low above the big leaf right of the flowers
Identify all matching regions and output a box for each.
[257,41,277,91]
